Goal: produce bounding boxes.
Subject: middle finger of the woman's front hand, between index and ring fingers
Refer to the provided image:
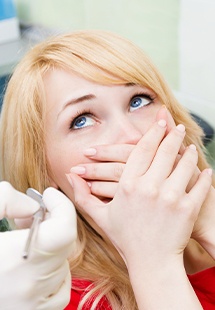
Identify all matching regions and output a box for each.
[148,124,185,182]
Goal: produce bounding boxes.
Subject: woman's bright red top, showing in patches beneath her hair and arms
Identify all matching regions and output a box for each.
[64,267,215,310]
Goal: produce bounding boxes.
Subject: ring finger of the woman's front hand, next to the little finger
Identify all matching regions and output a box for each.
[166,145,198,195]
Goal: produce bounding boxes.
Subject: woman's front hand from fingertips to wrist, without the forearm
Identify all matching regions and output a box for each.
[67,118,211,261]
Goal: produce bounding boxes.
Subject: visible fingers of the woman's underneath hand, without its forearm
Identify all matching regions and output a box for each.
[71,107,171,200]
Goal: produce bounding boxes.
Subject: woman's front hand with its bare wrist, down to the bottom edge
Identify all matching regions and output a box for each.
[69,120,211,310]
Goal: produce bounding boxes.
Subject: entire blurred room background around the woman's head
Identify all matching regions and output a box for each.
[0,0,215,167]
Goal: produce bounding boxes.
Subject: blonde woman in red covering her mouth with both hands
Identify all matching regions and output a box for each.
[1,31,215,310]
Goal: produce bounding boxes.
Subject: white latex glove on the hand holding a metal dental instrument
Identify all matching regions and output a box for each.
[0,182,77,310]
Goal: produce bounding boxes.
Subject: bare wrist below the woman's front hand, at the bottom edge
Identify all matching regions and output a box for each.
[128,257,202,310]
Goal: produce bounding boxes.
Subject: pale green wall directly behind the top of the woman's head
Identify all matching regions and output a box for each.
[15,0,180,89]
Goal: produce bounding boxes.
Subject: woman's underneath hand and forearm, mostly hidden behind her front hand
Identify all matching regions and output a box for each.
[71,109,215,269]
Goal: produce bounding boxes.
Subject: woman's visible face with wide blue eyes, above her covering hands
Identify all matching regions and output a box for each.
[44,69,161,199]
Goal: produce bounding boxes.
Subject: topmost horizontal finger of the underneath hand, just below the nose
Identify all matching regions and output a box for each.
[84,144,134,163]
